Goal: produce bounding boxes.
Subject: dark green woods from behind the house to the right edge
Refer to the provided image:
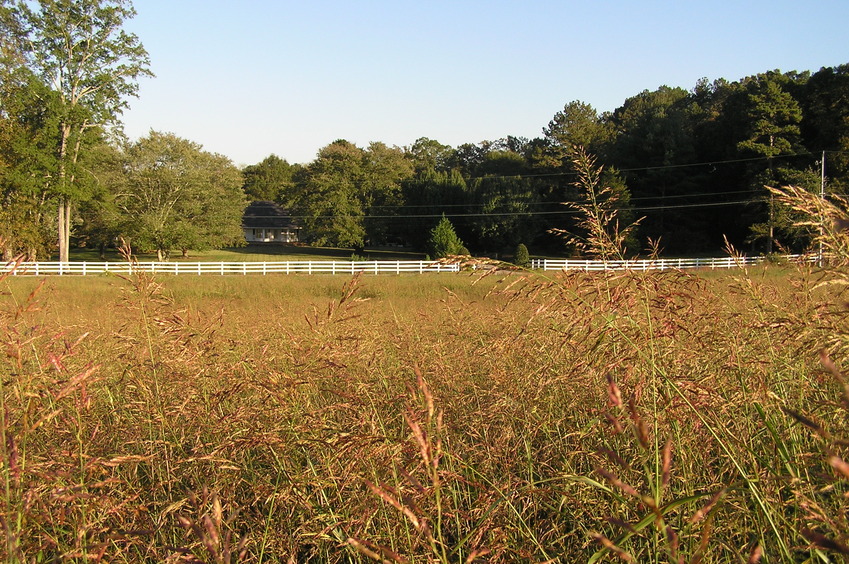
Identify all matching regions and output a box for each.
[243,65,849,253]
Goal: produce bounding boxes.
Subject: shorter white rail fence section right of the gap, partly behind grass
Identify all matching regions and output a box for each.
[531,255,818,271]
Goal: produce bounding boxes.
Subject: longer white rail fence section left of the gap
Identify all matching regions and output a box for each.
[0,260,460,276]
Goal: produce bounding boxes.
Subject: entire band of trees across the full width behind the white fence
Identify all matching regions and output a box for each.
[0,0,849,260]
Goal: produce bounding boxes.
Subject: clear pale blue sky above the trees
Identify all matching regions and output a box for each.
[119,0,849,166]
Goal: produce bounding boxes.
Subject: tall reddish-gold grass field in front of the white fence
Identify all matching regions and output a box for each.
[0,189,849,564]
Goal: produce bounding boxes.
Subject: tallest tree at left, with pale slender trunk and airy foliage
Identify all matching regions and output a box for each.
[4,0,151,261]
